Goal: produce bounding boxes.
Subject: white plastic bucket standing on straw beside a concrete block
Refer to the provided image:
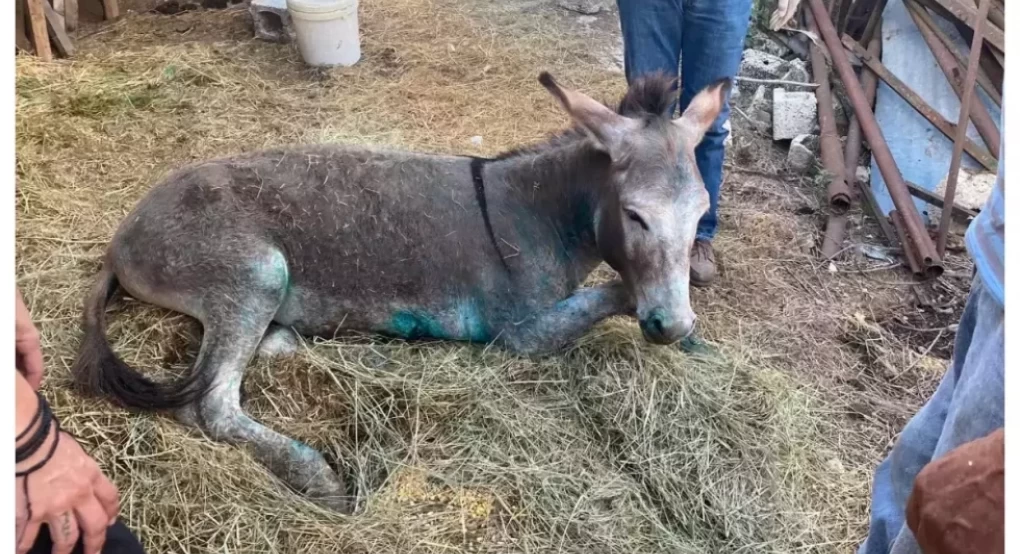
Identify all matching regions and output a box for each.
[287,0,361,65]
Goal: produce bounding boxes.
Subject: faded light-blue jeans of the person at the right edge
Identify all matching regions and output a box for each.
[858,278,1005,554]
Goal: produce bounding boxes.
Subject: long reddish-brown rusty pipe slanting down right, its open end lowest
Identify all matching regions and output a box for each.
[808,0,941,267]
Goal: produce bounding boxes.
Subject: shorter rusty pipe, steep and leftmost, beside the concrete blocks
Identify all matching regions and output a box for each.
[804,12,851,214]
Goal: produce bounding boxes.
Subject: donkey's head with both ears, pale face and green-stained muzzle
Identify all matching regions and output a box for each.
[539,72,729,344]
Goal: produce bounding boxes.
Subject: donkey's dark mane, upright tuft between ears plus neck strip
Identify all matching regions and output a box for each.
[494,71,676,160]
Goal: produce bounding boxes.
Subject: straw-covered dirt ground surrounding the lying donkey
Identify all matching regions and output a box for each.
[16,0,970,552]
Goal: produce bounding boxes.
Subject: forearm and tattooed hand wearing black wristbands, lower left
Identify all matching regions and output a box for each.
[14,371,119,554]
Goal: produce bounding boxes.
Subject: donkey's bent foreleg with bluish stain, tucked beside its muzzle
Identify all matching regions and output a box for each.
[500,282,634,354]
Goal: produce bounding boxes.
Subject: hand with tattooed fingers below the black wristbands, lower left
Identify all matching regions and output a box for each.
[15,424,119,554]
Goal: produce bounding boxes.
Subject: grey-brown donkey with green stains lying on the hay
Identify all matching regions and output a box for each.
[72,72,729,512]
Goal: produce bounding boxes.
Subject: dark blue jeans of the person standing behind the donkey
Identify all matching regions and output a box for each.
[616,0,752,241]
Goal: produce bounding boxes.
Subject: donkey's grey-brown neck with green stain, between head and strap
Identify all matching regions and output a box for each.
[483,137,609,279]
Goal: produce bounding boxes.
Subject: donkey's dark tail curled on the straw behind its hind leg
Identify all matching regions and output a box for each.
[71,263,208,410]
